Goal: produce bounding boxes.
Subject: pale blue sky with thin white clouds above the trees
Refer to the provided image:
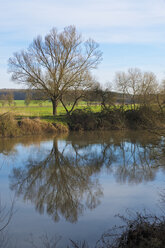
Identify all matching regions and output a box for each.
[0,0,165,88]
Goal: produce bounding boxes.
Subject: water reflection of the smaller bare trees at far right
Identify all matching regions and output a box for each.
[113,133,165,183]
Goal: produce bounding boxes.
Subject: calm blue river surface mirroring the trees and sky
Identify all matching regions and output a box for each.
[0,131,165,248]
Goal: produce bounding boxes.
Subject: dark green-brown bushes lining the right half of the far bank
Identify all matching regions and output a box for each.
[68,106,165,131]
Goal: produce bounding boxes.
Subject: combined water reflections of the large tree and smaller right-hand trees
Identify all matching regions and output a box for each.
[10,132,164,222]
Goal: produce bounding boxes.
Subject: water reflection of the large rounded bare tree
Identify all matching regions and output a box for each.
[11,139,103,222]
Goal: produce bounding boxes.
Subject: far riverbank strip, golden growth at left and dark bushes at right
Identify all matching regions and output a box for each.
[0,105,165,137]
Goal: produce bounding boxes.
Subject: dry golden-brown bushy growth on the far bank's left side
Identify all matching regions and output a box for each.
[0,113,68,137]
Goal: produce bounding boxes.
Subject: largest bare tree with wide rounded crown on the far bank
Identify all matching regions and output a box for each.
[9,26,102,115]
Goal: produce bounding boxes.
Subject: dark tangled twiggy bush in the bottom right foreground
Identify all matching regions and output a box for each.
[70,213,165,248]
